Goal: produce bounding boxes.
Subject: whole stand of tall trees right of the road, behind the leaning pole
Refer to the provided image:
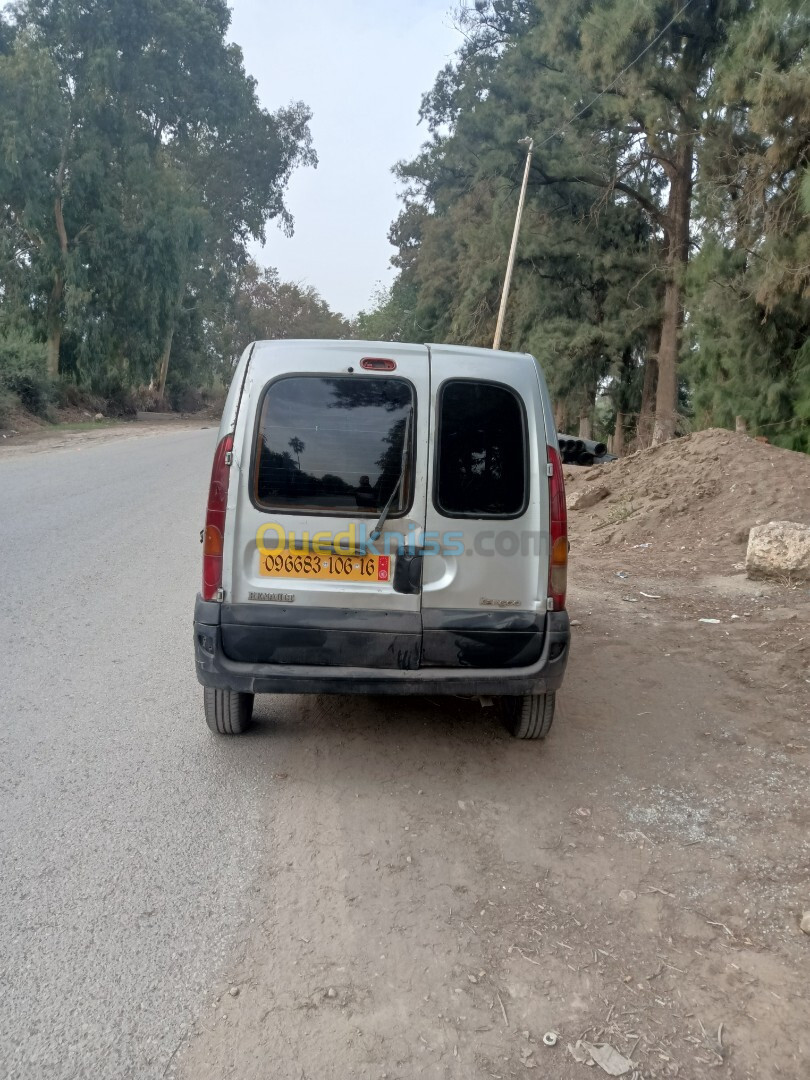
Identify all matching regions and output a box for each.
[360,0,810,453]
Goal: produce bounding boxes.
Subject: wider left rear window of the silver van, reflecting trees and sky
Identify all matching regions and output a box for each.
[254,375,416,517]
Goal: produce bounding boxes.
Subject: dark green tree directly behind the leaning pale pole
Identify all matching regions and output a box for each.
[392,2,657,438]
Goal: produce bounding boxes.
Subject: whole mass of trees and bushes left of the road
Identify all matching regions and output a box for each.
[0,0,348,427]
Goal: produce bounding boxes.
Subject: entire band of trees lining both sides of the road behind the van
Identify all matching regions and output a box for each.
[0,0,810,454]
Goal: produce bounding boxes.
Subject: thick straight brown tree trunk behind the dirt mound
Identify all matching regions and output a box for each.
[652,135,694,445]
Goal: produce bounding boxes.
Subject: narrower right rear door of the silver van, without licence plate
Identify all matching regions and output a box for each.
[422,346,549,667]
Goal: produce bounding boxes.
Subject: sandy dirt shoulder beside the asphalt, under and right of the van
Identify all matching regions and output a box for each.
[167,548,810,1080]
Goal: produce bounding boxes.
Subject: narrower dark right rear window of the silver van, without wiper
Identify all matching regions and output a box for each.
[436,379,527,517]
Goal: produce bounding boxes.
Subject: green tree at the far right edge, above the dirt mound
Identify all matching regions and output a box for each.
[686,0,810,450]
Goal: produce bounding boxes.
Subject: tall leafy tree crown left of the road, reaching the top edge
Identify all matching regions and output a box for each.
[0,0,314,390]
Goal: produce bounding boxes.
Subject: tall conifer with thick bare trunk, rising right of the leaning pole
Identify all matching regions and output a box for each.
[555,0,751,442]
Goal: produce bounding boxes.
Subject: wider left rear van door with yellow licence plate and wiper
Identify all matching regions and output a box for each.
[222,341,430,669]
